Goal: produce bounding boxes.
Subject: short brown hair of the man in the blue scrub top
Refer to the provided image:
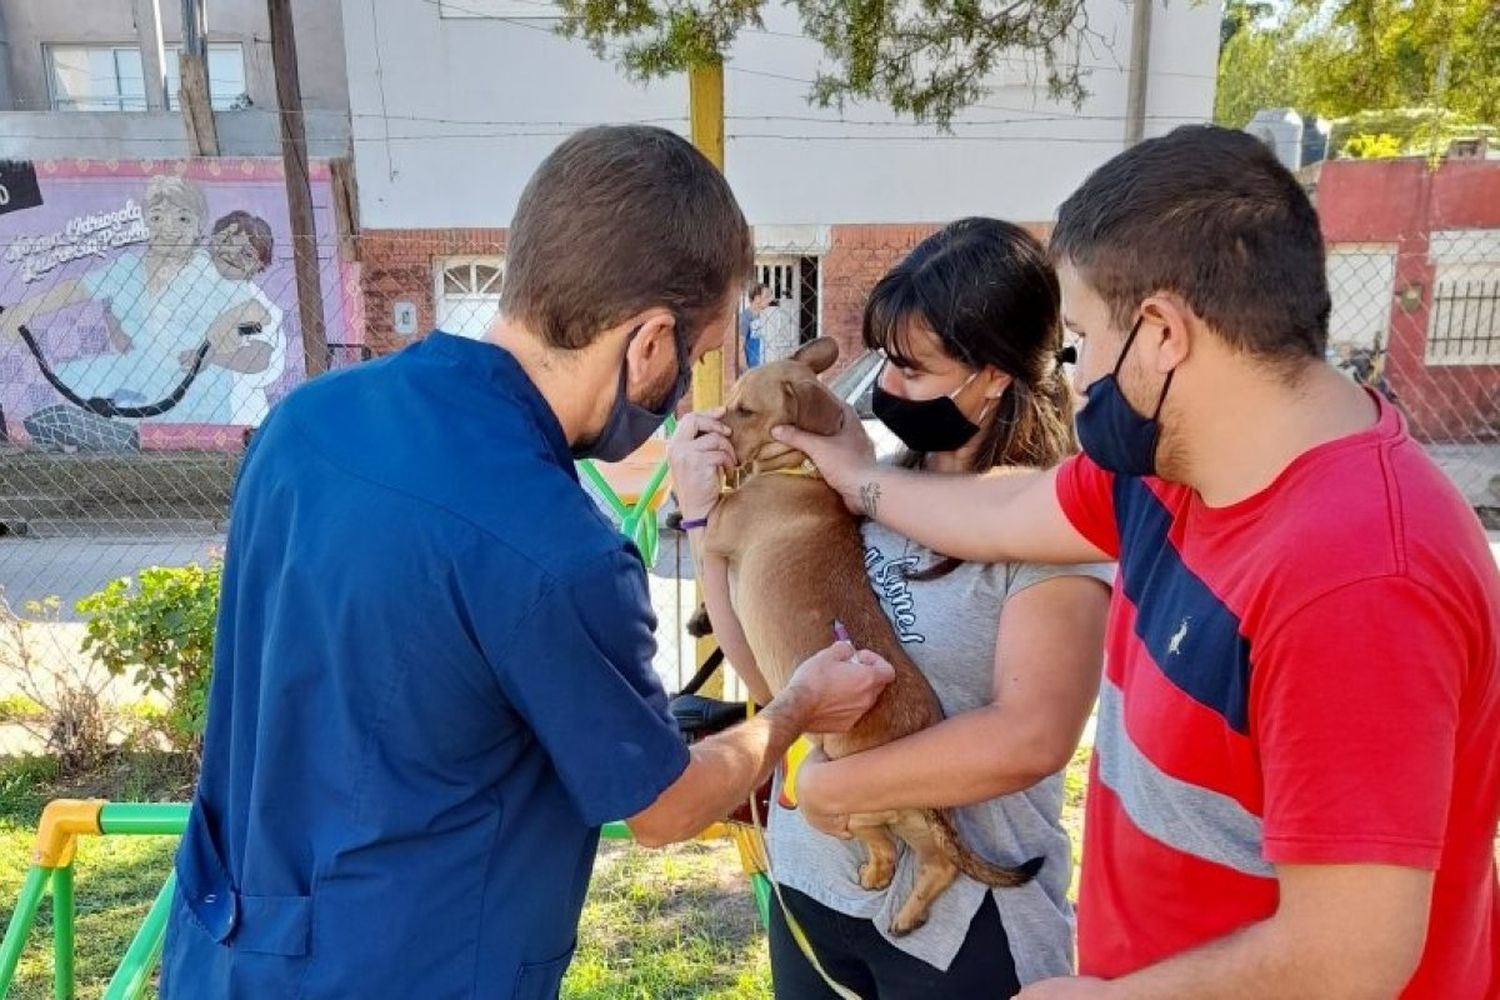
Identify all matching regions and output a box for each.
[501,124,753,349]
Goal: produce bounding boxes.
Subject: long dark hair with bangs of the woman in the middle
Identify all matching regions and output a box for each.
[863,217,1079,580]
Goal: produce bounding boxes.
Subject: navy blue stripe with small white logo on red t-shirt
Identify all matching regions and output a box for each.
[1115,475,1250,735]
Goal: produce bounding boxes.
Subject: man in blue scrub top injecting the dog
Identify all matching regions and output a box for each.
[162,126,891,1000]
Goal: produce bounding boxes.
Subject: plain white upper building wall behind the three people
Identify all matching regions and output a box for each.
[344,0,1218,228]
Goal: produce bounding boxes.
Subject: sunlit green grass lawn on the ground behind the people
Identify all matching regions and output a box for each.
[0,750,1500,1000]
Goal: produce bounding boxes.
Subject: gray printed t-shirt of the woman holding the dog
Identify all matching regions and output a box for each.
[768,522,1113,984]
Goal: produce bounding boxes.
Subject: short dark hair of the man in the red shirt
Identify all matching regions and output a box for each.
[1052,124,1331,361]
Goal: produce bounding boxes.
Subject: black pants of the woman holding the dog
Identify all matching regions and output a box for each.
[770,886,1022,1000]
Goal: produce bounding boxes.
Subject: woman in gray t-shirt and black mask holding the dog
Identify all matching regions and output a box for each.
[669,219,1110,1000]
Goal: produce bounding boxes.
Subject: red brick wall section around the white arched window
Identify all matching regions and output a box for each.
[360,229,506,354]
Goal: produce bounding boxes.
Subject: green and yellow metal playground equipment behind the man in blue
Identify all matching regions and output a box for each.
[0,443,771,1000]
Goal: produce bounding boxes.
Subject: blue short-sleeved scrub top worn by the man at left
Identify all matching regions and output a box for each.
[162,333,687,1000]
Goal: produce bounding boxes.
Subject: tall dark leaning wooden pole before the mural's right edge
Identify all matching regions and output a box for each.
[267,0,329,378]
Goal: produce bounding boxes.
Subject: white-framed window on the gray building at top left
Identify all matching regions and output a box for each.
[47,42,249,111]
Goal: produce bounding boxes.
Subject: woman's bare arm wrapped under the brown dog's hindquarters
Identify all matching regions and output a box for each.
[797,576,1109,832]
